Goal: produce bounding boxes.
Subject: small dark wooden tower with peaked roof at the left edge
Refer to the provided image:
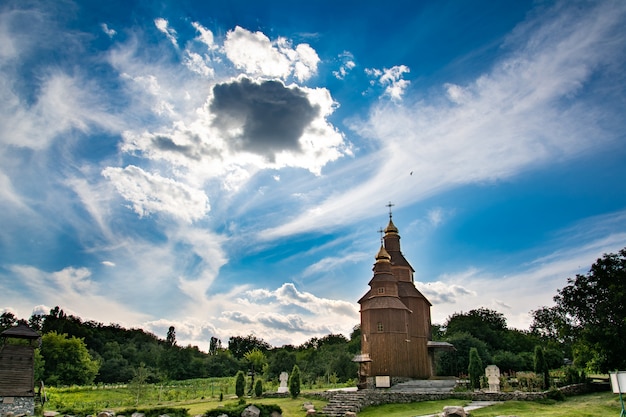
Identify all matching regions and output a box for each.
[0,323,40,415]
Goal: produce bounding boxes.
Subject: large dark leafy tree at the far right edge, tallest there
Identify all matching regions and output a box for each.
[554,248,626,372]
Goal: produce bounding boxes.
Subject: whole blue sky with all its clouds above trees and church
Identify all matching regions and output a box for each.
[0,0,626,350]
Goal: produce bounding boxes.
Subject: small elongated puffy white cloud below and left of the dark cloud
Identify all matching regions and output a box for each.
[102,165,210,222]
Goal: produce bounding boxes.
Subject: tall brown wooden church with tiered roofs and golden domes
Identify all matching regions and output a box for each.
[359,211,434,383]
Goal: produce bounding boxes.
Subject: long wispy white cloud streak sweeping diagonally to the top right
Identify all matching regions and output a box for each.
[263,0,626,238]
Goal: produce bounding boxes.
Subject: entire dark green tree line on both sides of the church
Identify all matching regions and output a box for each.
[0,248,626,389]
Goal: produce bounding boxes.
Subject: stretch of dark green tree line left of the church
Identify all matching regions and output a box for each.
[0,306,360,385]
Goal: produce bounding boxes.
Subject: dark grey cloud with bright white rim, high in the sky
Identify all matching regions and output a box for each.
[210,78,320,161]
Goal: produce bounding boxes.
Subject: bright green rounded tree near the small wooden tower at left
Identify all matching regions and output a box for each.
[41,332,99,385]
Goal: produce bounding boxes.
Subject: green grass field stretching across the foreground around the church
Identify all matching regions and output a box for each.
[45,378,621,417]
